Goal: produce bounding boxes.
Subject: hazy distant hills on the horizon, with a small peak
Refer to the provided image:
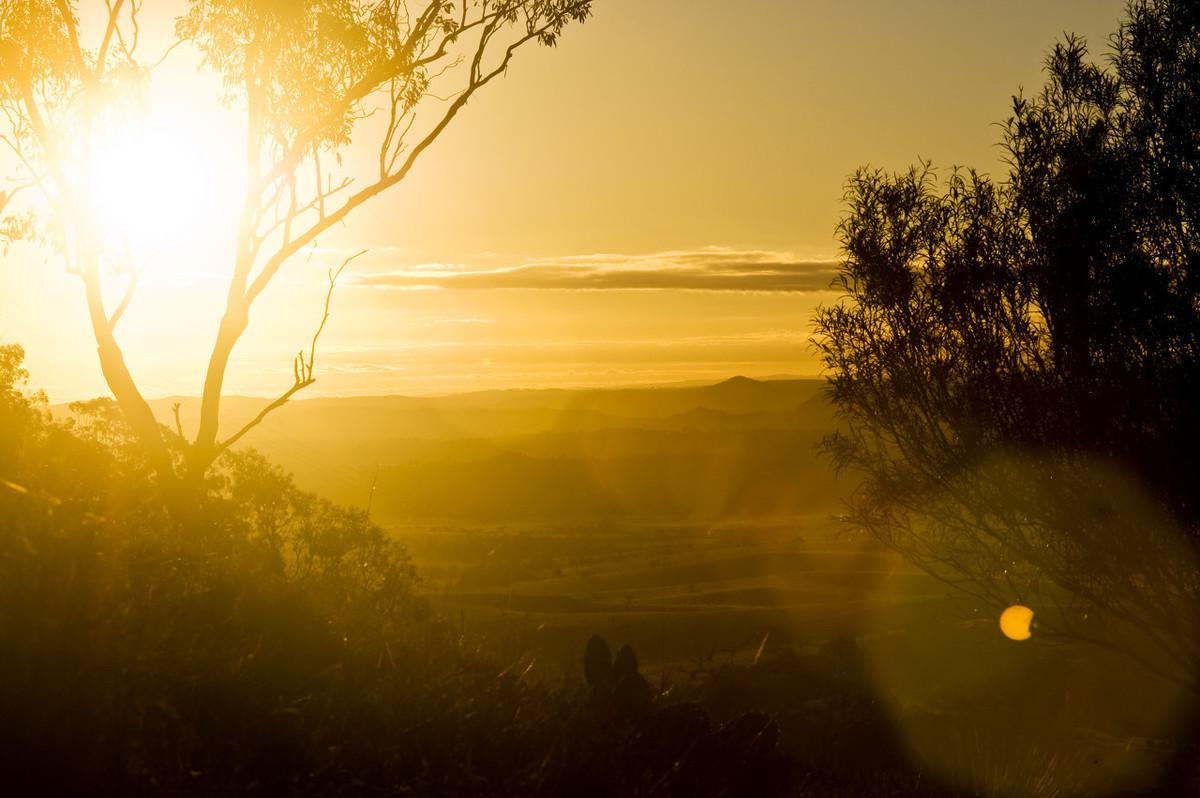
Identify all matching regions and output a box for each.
[145,377,851,523]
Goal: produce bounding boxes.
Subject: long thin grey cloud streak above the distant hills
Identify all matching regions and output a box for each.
[355,247,838,292]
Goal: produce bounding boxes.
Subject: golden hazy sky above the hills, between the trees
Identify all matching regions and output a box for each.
[0,0,1123,401]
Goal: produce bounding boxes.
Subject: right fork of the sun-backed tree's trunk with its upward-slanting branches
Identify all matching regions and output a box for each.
[181,0,590,470]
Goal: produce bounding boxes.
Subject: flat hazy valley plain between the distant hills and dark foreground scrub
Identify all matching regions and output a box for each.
[396,518,944,672]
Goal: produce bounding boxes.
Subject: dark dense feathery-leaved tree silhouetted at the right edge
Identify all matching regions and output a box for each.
[815,0,1200,682]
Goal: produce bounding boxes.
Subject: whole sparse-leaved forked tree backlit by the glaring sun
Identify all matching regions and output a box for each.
[0,0,592,480]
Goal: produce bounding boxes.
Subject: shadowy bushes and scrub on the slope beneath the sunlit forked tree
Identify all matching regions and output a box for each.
[0,347,796,796]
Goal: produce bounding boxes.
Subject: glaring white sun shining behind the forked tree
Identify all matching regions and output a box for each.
[85,103,241,269]
